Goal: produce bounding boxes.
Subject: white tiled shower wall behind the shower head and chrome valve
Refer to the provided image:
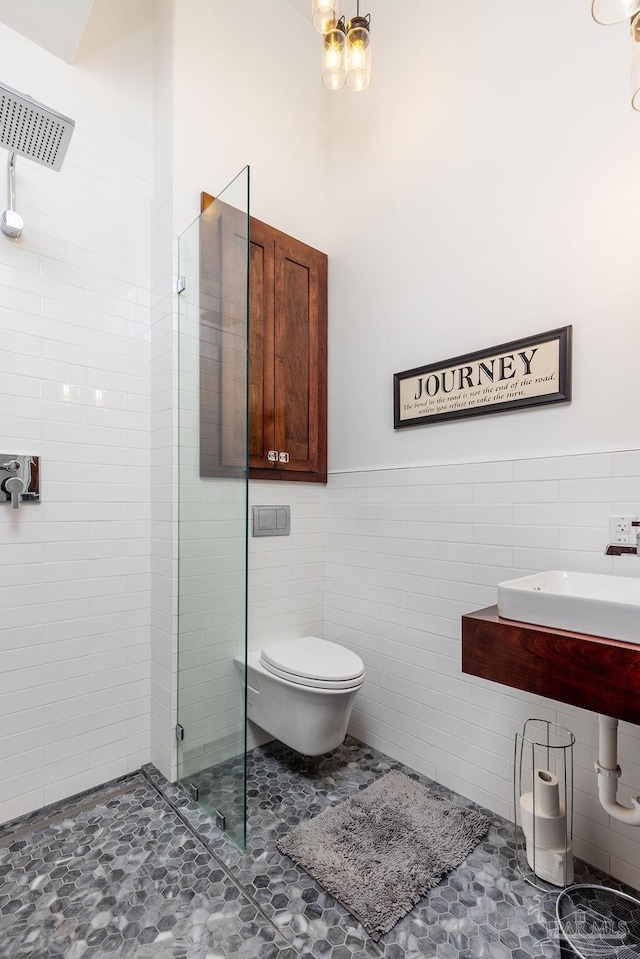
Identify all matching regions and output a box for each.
[0,0,152,821]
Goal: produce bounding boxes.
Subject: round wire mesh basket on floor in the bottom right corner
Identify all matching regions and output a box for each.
[556,883,640,959]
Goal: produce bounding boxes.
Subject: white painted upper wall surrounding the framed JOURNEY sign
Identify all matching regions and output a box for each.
[328,0,640,471]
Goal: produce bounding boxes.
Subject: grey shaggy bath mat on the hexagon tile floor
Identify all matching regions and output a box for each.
[278,772,489,942]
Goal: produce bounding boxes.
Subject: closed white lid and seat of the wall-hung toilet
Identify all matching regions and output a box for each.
[260,636,364,689]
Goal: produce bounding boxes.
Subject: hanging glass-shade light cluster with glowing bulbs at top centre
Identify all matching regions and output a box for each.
[311,0,370,93]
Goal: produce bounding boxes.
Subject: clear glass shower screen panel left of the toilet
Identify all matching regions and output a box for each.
[177,167,249,848]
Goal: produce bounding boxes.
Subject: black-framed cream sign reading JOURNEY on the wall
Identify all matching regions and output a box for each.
[393,326,571,430]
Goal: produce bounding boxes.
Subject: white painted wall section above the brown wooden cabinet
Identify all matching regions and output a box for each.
[174,0,330,250]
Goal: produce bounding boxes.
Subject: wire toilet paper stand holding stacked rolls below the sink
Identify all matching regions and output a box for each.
[513,719,575,892]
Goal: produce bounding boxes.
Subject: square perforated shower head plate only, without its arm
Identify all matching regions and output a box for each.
[0,83,75,171]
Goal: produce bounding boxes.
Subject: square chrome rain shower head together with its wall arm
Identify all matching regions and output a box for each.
[0,83,75,240]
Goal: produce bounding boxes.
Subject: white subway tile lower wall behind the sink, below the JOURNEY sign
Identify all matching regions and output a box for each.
[324,451,640,888]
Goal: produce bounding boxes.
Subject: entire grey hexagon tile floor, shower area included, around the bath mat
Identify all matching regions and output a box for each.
[0,737,633,959]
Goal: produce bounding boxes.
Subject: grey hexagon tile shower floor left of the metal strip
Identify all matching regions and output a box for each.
[0,775,291,959]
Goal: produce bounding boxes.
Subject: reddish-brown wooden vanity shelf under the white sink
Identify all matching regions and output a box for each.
[462,606,640,725]
